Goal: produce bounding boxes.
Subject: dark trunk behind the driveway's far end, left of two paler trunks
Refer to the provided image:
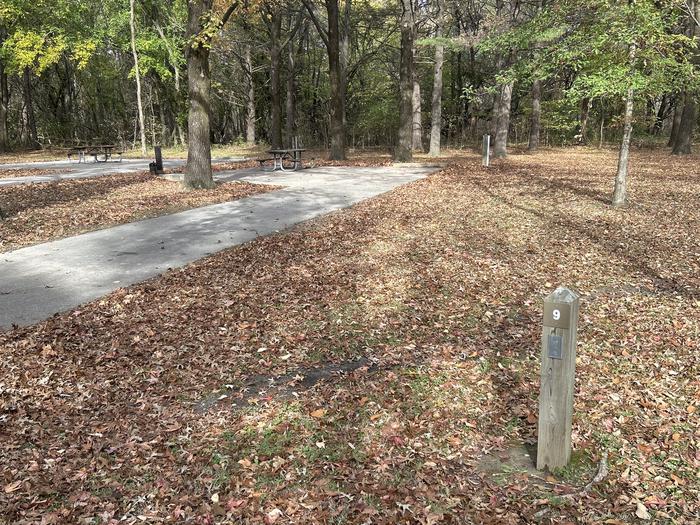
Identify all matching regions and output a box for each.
[394,0,415,162]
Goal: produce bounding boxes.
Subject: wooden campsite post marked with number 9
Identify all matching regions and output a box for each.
[537,286,580,470]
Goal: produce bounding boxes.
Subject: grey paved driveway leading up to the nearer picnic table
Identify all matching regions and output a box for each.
[0,167,435,328]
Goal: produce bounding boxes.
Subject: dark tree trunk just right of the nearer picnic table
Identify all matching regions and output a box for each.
[326,0,346,160]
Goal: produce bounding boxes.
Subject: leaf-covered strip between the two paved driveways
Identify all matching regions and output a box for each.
[0,173,275,252]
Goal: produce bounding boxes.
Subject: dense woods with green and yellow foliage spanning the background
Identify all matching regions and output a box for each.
[0,0,700,188]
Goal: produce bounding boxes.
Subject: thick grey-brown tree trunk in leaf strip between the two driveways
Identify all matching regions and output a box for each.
[183,0,214,189]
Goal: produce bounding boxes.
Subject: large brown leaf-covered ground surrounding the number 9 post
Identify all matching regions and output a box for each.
[0,147,700,525]
